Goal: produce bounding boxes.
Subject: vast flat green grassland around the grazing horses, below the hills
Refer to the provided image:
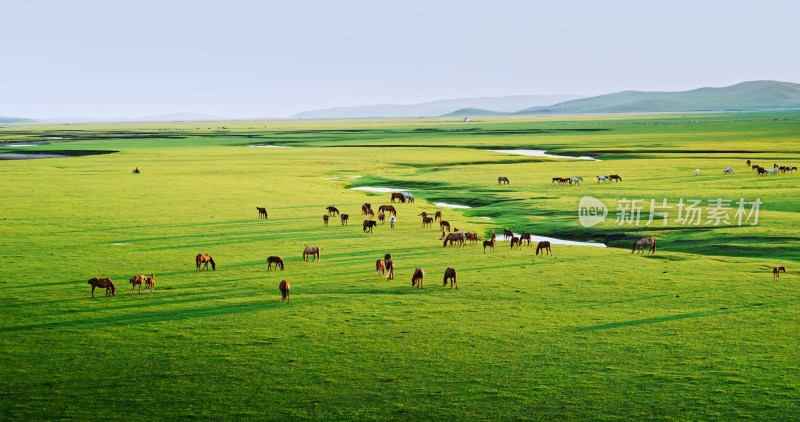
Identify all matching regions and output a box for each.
[0,113,800,420]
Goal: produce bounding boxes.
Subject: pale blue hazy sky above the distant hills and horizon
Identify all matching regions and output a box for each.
[0,0,800,118]
